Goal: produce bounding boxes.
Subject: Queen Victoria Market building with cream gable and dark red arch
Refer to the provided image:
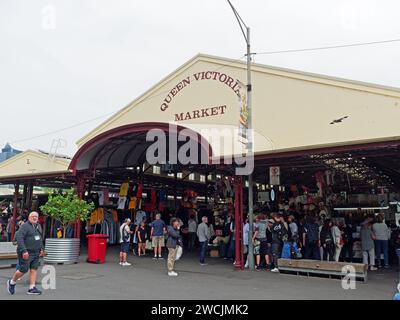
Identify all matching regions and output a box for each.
[0,54,400,268]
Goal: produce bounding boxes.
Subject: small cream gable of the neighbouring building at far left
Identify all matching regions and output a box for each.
[0,150,69,177]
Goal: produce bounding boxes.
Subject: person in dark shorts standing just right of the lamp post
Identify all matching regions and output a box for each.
[253,214,272,269]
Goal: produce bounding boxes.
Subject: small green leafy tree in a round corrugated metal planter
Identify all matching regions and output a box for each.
[40,193,94,263]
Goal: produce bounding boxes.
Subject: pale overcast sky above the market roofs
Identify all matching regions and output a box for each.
[0,0,400,156]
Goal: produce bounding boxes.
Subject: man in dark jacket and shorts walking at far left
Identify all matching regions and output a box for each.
[7,211,45,295]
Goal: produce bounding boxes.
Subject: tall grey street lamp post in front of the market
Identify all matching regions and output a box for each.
[227,0,254,270]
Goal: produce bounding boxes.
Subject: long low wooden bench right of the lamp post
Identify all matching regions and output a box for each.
[278,259,368,282]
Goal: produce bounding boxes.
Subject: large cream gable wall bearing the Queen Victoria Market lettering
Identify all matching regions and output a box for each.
[78,56,400,155]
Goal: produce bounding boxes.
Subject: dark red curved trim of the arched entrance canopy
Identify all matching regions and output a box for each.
[69,122,217,174]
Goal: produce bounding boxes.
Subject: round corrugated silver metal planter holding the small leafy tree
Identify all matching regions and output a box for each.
[44,238,80,264]
